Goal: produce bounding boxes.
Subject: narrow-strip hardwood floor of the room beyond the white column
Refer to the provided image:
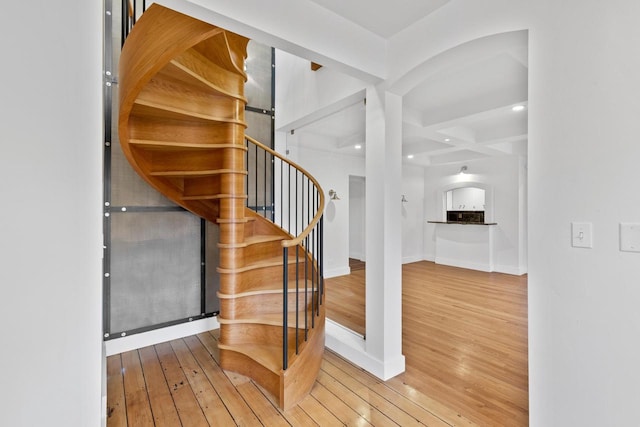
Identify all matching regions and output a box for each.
[325,261,529,426]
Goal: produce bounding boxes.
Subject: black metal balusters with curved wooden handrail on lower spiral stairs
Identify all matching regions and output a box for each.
[245,136,324,369]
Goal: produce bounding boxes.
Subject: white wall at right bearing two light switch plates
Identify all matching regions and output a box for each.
[529,0,640,426]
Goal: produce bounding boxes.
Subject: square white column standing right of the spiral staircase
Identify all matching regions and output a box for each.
[366,87,404,379]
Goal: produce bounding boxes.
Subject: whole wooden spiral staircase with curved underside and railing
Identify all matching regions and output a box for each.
[119,4,325,409]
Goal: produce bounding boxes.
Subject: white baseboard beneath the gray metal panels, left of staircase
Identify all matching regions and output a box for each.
[104,317,220,356]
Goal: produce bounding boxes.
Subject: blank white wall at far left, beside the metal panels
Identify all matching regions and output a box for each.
[0,0,103,427]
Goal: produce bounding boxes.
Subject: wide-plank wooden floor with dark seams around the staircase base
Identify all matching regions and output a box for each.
[107,331,460,427]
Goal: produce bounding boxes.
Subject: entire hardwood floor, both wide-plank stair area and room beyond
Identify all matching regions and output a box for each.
[107,262,528,427]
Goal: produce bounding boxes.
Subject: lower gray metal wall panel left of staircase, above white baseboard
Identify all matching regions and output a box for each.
[110,212,200,332]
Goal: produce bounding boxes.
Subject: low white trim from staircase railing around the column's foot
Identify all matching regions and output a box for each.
[325,319,405,381]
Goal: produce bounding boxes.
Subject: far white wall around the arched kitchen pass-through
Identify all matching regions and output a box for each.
[424,156,526,274]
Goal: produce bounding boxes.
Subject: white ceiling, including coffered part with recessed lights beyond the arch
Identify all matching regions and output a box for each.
[288,0,528,166]
